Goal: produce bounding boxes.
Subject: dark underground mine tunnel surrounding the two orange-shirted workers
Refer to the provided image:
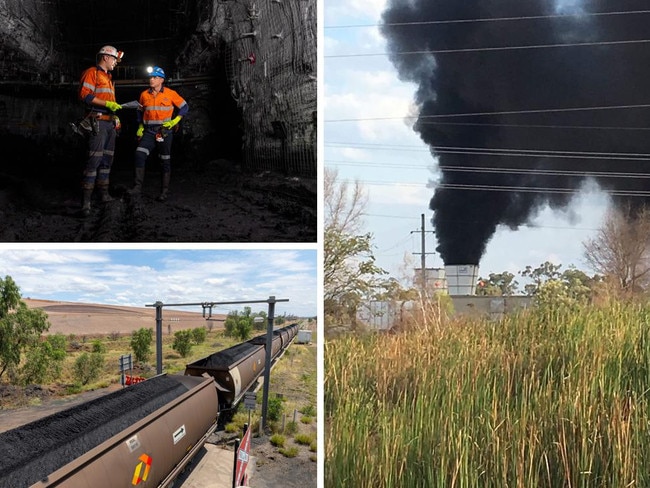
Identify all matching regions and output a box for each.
[0,0,317,242]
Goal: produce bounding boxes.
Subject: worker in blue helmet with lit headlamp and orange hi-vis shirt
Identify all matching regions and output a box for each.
[131,66,190,202]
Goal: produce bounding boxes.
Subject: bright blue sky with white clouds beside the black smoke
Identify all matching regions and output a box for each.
[323,0,607,282]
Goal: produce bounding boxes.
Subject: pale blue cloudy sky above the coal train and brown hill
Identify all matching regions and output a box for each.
[0,248,318,317]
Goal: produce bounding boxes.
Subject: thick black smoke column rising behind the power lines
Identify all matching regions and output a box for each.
[382,0,650,264]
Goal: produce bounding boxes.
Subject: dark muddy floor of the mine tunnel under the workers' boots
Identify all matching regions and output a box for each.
[0,160,317,243]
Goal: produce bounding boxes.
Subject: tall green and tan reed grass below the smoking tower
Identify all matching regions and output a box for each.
[325,304,650,488]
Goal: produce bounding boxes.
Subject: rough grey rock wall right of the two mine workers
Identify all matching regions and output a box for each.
[177,0,317,175]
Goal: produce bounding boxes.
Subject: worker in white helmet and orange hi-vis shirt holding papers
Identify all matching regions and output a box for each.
[79,46,124,215]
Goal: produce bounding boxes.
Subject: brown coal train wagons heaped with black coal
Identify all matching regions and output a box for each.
[0,324,299,488]
